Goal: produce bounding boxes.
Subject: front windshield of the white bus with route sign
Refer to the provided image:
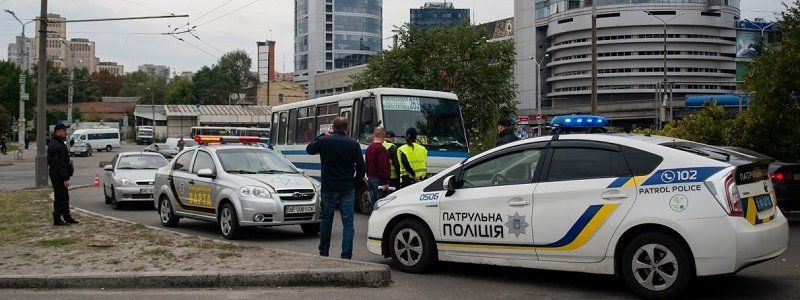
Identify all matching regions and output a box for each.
[382,96,467,151]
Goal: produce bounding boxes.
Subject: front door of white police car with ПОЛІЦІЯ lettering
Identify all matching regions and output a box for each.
[434,144,546,260]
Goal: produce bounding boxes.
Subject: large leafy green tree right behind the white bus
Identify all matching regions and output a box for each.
[354,24,516,152]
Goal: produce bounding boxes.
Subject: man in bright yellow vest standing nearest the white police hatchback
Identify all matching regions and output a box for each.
[397,127,428,187]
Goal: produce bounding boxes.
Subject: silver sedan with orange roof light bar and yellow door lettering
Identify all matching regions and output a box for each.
[155,144,320,239]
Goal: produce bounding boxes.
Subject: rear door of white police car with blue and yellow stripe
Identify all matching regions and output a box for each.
[533,141,636,262]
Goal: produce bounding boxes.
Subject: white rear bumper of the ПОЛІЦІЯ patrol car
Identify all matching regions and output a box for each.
[680,212,789,276]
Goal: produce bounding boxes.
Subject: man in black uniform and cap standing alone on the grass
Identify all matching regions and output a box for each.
[47,124,78,226]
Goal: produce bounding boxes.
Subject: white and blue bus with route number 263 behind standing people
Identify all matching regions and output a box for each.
[270,88,469,212]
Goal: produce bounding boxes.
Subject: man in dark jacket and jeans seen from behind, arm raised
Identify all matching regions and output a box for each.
[306,117,364,259]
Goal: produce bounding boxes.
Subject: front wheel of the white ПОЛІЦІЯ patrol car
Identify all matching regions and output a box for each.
[388,219,438,273]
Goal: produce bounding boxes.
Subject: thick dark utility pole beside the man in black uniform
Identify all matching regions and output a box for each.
[35,0,47,187]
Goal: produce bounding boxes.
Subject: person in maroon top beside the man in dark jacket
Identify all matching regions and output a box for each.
[365,127,391,212]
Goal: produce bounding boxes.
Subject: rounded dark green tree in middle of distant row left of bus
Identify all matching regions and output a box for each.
[192,66,236,105]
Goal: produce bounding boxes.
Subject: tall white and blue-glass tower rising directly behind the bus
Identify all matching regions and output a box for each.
[294,0,383,98]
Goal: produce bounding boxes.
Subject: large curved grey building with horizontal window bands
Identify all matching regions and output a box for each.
[514,0,740,127]
